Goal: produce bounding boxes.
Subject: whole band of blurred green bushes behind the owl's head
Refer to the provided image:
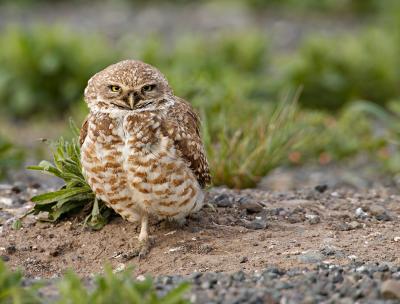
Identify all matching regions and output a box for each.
[0,26,400,121]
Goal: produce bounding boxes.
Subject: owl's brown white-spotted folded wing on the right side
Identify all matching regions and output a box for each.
[162,97,211,187]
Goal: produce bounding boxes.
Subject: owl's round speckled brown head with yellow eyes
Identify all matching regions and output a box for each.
[85,60,173,111]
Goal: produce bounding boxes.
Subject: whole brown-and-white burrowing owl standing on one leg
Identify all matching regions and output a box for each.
[80,60,210,255]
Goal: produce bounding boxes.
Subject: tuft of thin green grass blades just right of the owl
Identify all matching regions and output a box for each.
[203,95,304,188]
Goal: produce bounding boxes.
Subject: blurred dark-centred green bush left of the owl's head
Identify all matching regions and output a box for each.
[0,26,116,119]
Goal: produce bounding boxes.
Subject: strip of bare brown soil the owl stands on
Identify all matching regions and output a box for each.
[0,185,400,278]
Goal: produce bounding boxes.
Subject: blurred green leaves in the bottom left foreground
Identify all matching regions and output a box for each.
[0,260,190,304]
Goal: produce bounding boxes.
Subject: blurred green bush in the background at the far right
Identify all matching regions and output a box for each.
[282,30,400,110]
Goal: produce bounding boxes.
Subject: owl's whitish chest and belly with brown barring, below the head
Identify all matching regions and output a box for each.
[81,110,204,221]
